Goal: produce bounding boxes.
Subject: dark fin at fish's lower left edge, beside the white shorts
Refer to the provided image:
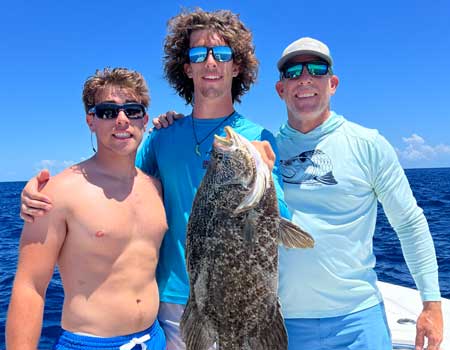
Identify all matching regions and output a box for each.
[180,299,214,350]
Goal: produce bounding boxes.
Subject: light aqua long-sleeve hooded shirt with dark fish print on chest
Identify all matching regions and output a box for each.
[277,112,440,318]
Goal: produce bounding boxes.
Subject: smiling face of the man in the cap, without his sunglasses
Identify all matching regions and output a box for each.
[276,55,339,133]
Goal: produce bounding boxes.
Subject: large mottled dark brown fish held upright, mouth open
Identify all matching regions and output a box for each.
[180,127,314,350]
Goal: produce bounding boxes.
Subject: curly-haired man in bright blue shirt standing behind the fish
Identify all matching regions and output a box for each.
[136,10,289,349]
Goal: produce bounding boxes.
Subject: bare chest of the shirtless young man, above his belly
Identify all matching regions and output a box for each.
[62,186,167,256]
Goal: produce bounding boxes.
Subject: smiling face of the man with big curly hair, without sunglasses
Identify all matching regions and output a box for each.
[184,30,239,104]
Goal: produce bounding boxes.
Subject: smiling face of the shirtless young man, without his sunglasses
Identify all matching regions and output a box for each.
[86,85,148,157]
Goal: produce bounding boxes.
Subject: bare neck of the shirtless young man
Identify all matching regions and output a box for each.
[91,148,136,181]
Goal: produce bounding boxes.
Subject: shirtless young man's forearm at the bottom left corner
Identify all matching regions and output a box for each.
[6,285,44,350]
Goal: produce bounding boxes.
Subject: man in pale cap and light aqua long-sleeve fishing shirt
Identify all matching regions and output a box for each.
[276,38,443,350]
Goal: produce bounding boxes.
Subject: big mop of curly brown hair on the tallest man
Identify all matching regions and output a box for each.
[164,8,258,104]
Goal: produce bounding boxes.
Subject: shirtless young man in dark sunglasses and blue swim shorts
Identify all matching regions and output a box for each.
[6,68,167,350]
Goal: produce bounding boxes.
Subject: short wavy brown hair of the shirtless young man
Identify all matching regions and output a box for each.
[83,68,150,113]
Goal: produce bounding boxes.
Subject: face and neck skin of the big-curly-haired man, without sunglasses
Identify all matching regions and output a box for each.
[184,30,239,119]
